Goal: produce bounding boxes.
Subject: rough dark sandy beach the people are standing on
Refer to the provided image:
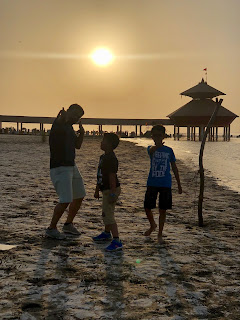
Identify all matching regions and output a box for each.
[0,135,240,320]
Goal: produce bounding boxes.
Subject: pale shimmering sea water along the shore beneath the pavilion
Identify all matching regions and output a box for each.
[124,138,240,193]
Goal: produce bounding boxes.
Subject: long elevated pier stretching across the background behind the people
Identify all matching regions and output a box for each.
[0,115,174,135]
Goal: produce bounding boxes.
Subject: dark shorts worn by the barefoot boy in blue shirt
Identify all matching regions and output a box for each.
[144,186,172,210]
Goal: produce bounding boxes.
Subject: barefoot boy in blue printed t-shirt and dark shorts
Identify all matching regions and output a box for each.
[144,125,182,244]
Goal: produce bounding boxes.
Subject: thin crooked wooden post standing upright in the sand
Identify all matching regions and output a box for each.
[198,98,223,227]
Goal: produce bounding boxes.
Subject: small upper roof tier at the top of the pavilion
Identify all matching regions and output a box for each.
[180,79,225,99]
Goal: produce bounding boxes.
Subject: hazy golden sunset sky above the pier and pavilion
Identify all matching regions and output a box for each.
[0,0,240,133]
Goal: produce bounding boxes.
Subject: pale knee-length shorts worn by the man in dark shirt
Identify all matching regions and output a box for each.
[50,166,86,203]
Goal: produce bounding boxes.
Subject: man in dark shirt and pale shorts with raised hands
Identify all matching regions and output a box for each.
[46,104,86,239]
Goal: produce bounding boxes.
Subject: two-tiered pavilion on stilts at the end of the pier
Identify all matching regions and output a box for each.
[168,79,238,141]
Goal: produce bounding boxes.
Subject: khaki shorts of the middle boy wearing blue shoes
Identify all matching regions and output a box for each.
[102,187,121,226]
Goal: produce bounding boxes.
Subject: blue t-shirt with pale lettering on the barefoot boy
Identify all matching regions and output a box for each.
[147,146,176,188]
